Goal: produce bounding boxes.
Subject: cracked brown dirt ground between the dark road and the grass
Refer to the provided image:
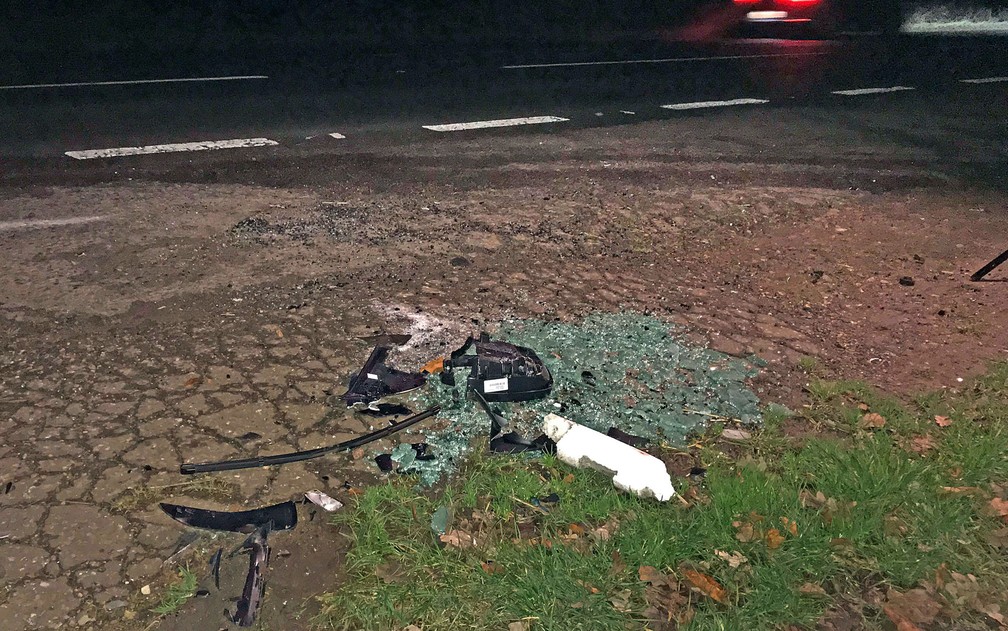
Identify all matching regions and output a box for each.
[0,114,1008,630]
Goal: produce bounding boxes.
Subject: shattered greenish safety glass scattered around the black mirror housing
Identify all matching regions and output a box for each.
[400,312,762,485]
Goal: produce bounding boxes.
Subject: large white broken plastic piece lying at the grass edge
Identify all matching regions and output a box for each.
[542,414,675,502]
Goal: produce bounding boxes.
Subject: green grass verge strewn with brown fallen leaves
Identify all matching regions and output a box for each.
[316,364,1008,630]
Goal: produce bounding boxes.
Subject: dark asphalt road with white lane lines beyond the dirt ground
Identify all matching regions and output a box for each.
[0,36,1008,159]
